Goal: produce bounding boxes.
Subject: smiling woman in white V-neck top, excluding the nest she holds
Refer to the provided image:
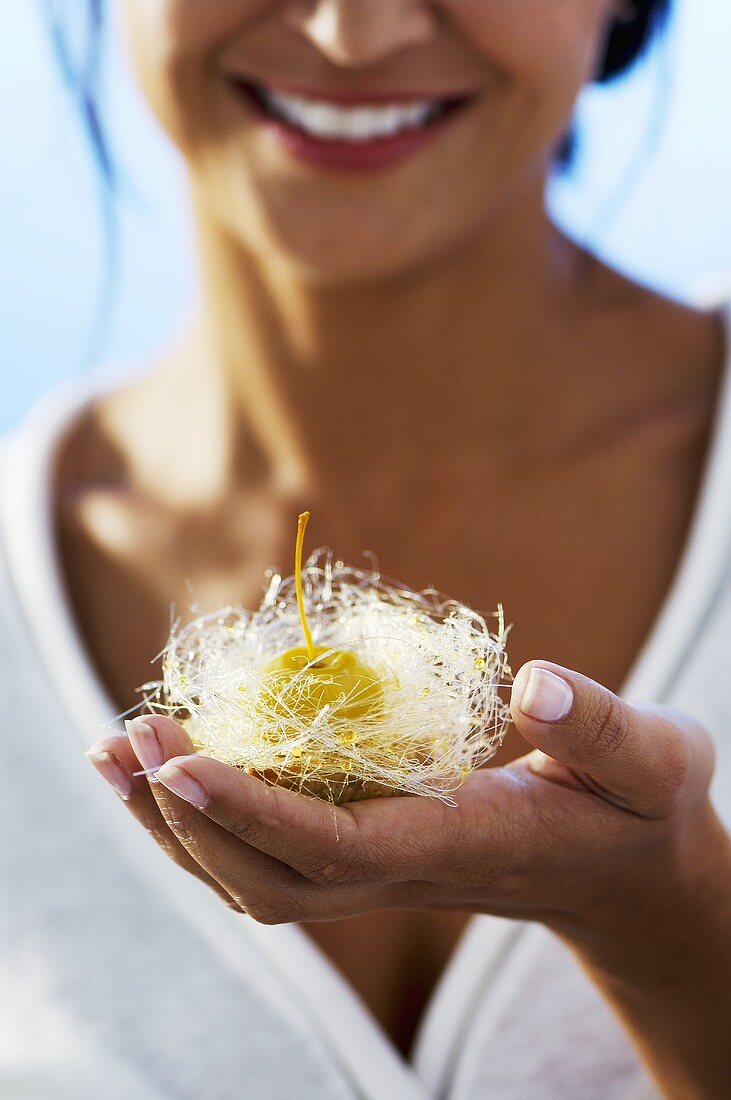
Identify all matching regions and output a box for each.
[0,0,731,1100]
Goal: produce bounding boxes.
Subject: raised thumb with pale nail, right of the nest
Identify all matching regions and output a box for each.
[510,661,712,817]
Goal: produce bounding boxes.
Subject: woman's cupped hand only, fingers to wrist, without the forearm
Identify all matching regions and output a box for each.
[88,661,718,936]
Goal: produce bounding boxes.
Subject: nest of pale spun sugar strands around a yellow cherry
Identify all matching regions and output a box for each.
[141,549,511,803]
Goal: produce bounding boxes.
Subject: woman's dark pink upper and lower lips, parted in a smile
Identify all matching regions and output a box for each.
[231,77,476,172]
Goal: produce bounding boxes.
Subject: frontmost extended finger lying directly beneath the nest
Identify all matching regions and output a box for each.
[152,755,484,884]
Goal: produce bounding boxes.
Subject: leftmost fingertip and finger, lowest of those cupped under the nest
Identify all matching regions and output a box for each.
[87,735,237,908]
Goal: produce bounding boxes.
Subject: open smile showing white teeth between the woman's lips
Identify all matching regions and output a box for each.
[234,79,475,146]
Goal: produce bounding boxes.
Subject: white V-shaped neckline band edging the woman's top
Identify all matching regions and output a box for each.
[0,306,731,1100]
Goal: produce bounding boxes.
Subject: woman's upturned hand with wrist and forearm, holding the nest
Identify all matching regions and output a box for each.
[90,661,731,1100]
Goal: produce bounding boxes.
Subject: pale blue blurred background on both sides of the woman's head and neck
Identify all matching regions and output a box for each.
[0,0,731,432]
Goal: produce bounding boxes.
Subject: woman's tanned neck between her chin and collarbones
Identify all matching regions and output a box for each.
[183,187,571,492]
